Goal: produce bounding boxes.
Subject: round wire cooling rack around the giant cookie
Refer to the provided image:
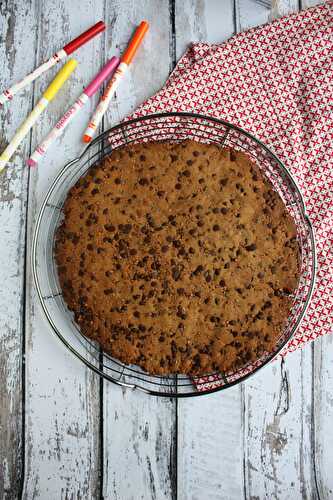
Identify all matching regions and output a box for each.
[32,113,316,397]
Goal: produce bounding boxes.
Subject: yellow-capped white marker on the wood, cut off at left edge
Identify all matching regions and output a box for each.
[0,59,77,172]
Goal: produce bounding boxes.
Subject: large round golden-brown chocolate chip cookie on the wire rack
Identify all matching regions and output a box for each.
[55,141,299,375]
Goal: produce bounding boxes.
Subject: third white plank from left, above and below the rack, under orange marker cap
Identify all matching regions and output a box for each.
[103,0,176,500]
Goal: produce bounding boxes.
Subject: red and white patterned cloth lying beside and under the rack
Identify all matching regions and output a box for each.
[128,2,333,390]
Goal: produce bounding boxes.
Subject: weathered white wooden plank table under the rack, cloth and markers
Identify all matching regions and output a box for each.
[0,0,333,500]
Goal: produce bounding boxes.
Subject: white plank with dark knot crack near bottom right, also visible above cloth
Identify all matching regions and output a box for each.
[238,0,315,499]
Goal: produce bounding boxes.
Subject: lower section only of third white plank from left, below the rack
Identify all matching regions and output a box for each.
[103,385,175,500]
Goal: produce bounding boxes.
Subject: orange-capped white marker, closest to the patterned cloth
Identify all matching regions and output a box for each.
[83,21,149,142]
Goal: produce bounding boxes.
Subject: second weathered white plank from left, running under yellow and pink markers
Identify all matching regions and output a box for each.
[24,0,104,499]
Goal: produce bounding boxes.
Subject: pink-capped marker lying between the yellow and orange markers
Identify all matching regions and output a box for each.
[27,57,120,167]
